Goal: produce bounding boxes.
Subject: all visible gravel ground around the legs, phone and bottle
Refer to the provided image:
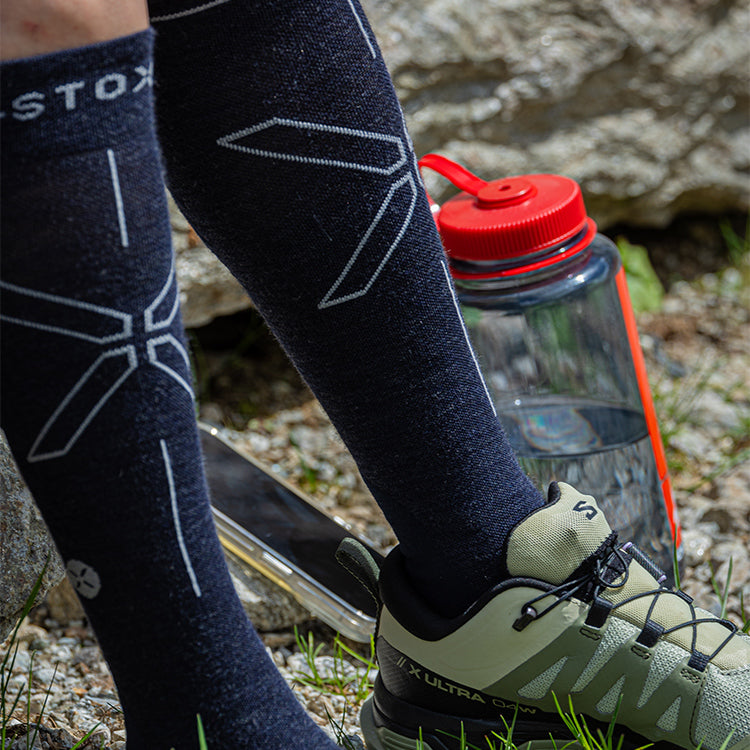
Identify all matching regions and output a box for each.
[0,260,750,750]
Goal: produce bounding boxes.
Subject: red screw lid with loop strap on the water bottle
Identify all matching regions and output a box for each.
[419,154,596,278]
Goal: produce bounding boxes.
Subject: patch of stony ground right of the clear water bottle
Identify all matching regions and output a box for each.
[639,270,750,621]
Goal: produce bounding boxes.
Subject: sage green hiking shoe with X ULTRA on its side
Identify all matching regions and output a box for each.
[340,484,750,750]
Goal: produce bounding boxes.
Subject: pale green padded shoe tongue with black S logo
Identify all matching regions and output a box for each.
[507,482,612,584]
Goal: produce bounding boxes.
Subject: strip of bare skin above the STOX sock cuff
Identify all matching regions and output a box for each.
[0,0,149,60]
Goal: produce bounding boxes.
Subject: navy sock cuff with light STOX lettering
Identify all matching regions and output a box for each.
[0,29,154,159]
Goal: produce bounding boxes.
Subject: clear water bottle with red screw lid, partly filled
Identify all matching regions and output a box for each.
[420,154,679,577]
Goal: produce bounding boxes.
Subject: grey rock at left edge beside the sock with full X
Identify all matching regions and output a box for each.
[0,431,65,643]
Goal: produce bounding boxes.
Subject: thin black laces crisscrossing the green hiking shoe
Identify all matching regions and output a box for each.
[513,534,738,672]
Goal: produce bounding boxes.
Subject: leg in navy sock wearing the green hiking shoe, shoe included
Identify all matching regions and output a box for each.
[151,7,750,750]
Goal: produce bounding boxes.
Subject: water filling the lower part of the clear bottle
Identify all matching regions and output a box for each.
[497,396,673,581]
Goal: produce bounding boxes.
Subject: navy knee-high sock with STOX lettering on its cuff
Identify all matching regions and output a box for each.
[0,32,334,750]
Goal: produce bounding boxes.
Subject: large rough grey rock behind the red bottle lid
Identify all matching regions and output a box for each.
[364,0,750,227]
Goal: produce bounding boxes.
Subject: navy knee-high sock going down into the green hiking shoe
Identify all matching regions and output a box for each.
[150,0,543,614]
